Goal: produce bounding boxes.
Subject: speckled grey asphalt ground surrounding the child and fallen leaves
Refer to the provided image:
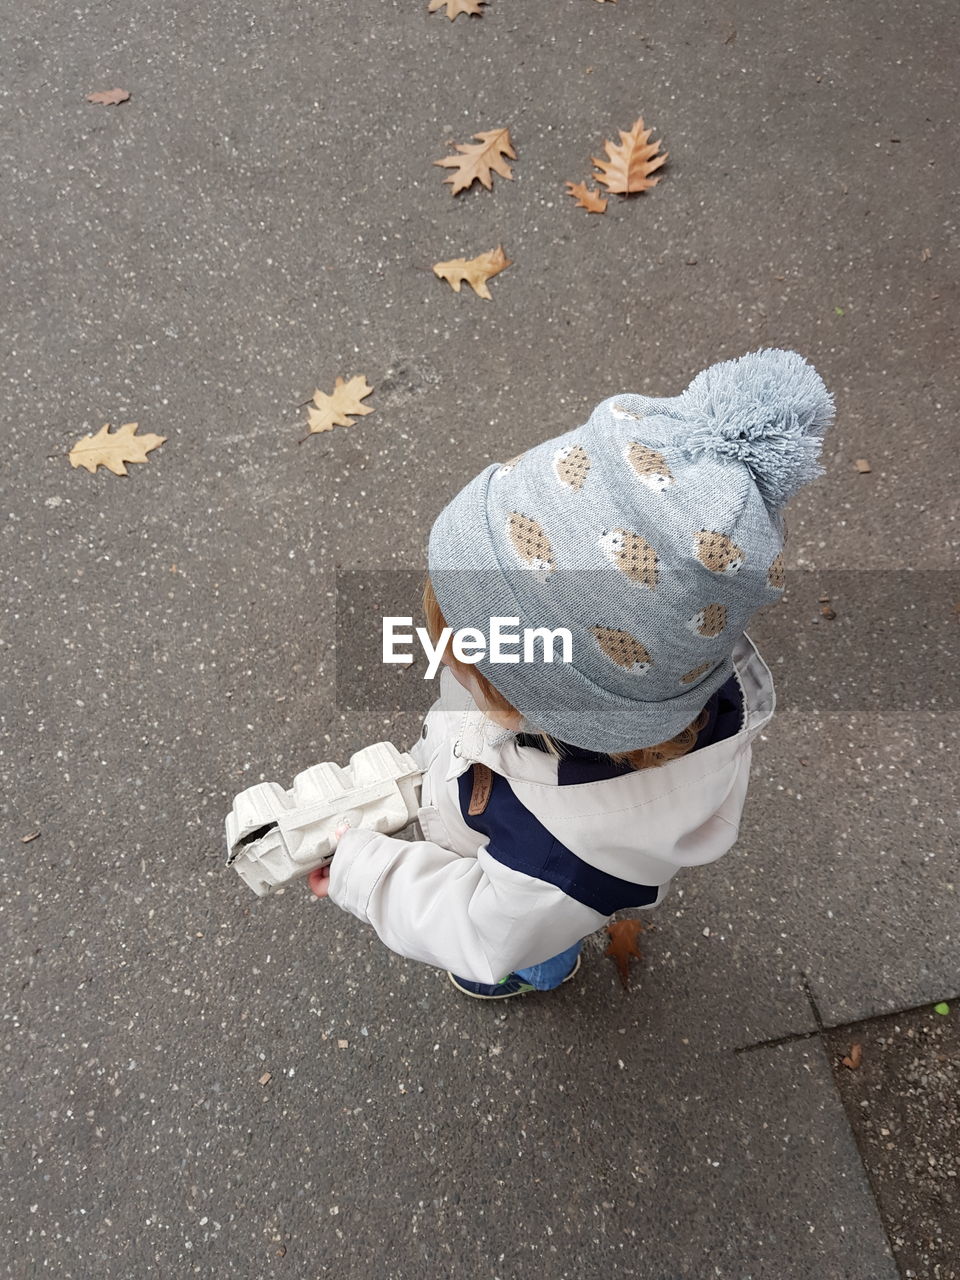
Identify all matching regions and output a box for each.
[0,0,960,1280]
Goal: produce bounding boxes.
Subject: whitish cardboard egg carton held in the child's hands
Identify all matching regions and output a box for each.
[227,742,421,897]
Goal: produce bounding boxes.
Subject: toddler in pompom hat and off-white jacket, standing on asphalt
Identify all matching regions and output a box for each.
[310,349,833,1000]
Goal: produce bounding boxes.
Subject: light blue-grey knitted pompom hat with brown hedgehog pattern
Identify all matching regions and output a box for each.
[428,349,833,751]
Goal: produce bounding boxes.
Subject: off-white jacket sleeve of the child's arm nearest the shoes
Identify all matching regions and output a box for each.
[330,829,608,983]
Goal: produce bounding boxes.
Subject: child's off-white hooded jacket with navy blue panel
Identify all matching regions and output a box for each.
[329,636,774,983]
